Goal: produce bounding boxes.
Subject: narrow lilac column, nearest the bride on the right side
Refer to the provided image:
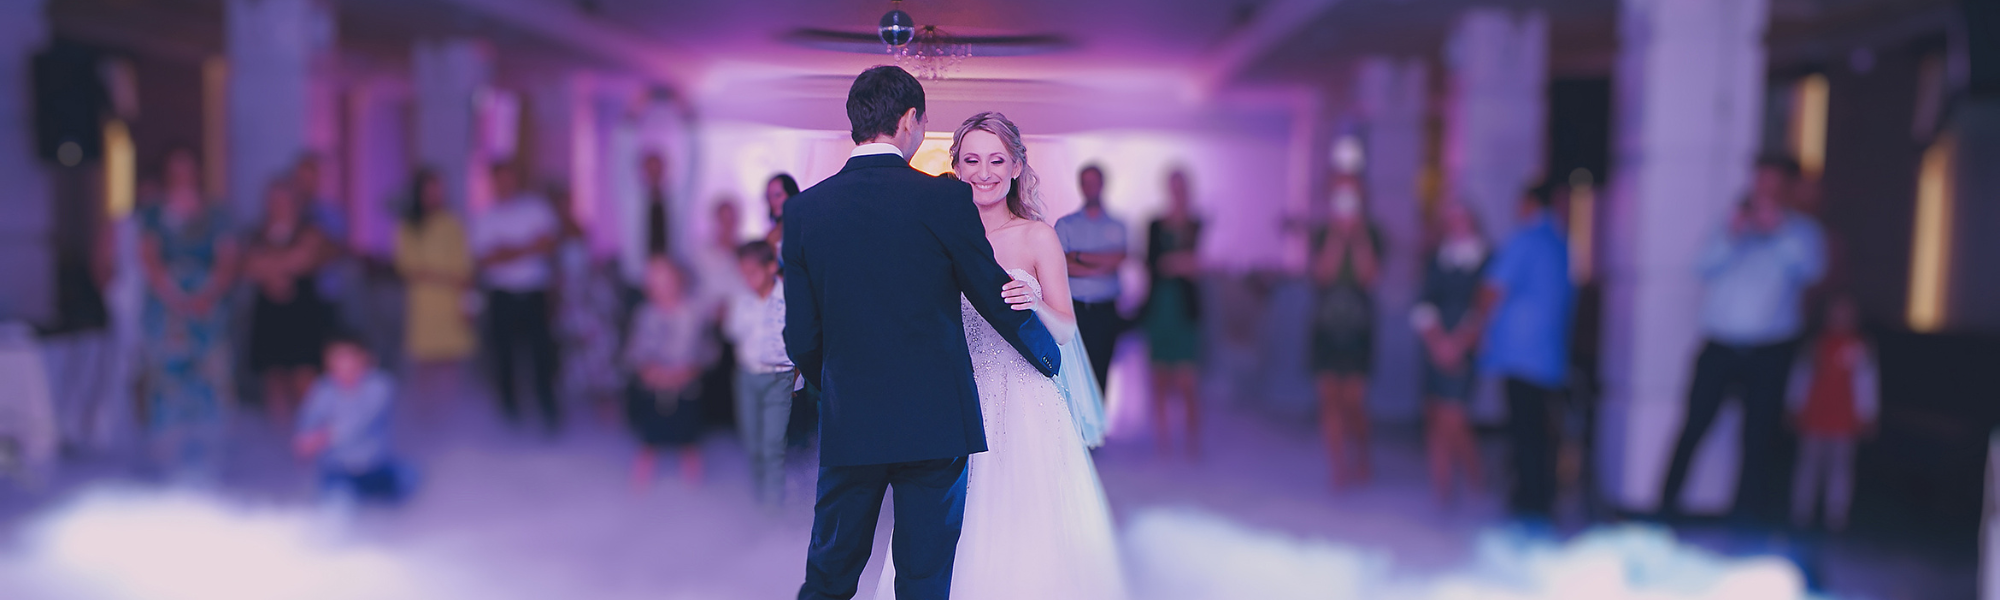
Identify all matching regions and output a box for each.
[1354,56,1430,420]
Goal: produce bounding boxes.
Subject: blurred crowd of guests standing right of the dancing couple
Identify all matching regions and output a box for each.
[1056,156,1878,530]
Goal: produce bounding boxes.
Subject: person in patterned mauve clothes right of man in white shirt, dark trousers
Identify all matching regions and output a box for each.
[546,188,624,400]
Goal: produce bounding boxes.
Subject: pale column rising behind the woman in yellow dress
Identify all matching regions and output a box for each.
[410,38,492,208]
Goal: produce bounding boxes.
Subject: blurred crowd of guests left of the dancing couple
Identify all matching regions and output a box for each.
[10,146,814,504]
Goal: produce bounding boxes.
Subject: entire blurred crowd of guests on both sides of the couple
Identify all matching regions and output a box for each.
[7,132,1878,530]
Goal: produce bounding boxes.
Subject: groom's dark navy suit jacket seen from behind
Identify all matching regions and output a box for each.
[784,154,1062,466]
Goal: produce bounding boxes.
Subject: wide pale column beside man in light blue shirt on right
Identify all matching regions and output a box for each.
[1600,0,1768,512]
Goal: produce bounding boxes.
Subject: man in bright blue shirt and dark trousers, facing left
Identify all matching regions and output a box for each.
[1458,186,1576,520]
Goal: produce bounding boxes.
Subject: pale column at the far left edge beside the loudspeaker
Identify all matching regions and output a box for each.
[0,0,56,320]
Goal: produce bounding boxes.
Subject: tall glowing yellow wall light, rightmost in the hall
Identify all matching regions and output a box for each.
[1908,136,1956,332]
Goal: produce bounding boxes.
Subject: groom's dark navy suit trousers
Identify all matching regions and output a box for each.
[798,456,966,600]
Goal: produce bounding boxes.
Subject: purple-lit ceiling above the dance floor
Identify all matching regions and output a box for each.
[48,0,1954,96]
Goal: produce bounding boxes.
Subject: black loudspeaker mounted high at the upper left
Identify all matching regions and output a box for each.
[34,40,110,166]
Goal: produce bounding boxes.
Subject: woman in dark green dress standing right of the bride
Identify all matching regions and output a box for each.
[1144,170,1202,454]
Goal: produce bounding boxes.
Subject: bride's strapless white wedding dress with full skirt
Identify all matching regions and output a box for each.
[876,270,1126,600]
